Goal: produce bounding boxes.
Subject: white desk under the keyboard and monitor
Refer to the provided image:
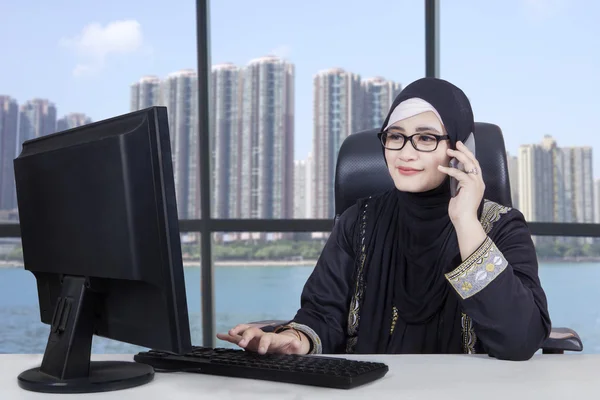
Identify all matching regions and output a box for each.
[0,354,600,400]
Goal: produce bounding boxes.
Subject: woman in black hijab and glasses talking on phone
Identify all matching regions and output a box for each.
[217,78,551,360]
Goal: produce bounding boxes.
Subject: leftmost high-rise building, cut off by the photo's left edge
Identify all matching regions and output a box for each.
[0,96,19,210]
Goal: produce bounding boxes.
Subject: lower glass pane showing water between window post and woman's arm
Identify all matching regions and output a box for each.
[213,232,329,347]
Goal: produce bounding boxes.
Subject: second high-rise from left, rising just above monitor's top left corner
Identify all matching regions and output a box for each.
[19,99,56,147]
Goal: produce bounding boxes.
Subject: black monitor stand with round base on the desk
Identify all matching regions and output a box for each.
[18,276,154,393]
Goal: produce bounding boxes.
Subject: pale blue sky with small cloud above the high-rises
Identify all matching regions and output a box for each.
[0,0,600,177]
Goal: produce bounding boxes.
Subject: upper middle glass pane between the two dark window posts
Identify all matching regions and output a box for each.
[211,0,425,219]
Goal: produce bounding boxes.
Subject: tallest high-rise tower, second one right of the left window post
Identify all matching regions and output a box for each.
[240,56,294,218]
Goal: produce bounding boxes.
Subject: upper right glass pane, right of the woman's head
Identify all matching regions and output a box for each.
[440,0,600,223]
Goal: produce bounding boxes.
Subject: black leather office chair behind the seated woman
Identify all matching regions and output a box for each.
[334,122,583,354]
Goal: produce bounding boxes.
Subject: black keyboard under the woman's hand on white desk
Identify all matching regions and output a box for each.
[134,346,388,389]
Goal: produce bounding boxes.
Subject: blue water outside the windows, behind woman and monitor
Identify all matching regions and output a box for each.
[0,263,600,353]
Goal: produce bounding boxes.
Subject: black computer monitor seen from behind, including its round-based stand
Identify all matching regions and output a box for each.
[14,107,191,393]
